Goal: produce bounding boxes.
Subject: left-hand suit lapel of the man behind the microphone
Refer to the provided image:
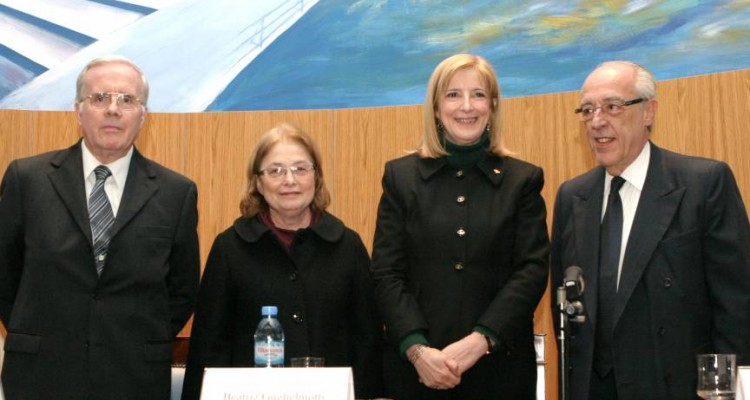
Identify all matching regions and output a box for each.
[573,168,604,326]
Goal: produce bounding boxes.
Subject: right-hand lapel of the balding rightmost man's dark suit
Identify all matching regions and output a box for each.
[615,144,685,323]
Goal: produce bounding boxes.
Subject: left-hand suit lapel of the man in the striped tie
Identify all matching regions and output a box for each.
[49,140,93,243]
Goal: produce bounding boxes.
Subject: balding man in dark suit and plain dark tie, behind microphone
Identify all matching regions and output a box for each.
[551,61,750,400]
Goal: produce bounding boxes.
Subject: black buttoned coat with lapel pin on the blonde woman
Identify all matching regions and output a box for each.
[372,154,549,399]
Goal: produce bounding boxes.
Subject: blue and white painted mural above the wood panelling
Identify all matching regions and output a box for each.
[0,0,750,112]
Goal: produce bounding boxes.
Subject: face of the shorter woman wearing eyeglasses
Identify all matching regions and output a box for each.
[256,140,316,228]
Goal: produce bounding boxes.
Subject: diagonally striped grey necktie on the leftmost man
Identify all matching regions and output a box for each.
[89,165,115,276]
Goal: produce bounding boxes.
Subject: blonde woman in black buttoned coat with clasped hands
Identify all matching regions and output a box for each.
[372,54,549,400]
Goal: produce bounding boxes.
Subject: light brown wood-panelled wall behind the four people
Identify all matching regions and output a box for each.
[0,69,750,400]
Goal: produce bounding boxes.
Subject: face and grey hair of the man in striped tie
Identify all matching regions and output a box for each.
[75,62,146,164]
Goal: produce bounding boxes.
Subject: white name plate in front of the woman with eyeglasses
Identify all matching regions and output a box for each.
[201,368,354,400]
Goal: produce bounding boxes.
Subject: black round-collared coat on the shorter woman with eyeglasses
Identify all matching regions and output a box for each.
[182,212,382,400]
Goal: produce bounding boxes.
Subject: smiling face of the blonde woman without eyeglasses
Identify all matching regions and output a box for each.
[435,68,492,145]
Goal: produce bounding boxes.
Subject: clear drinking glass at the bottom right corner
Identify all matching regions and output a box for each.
[696,354,737,400]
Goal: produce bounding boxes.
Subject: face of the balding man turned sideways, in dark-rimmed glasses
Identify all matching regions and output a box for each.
[581,64,657,175]
